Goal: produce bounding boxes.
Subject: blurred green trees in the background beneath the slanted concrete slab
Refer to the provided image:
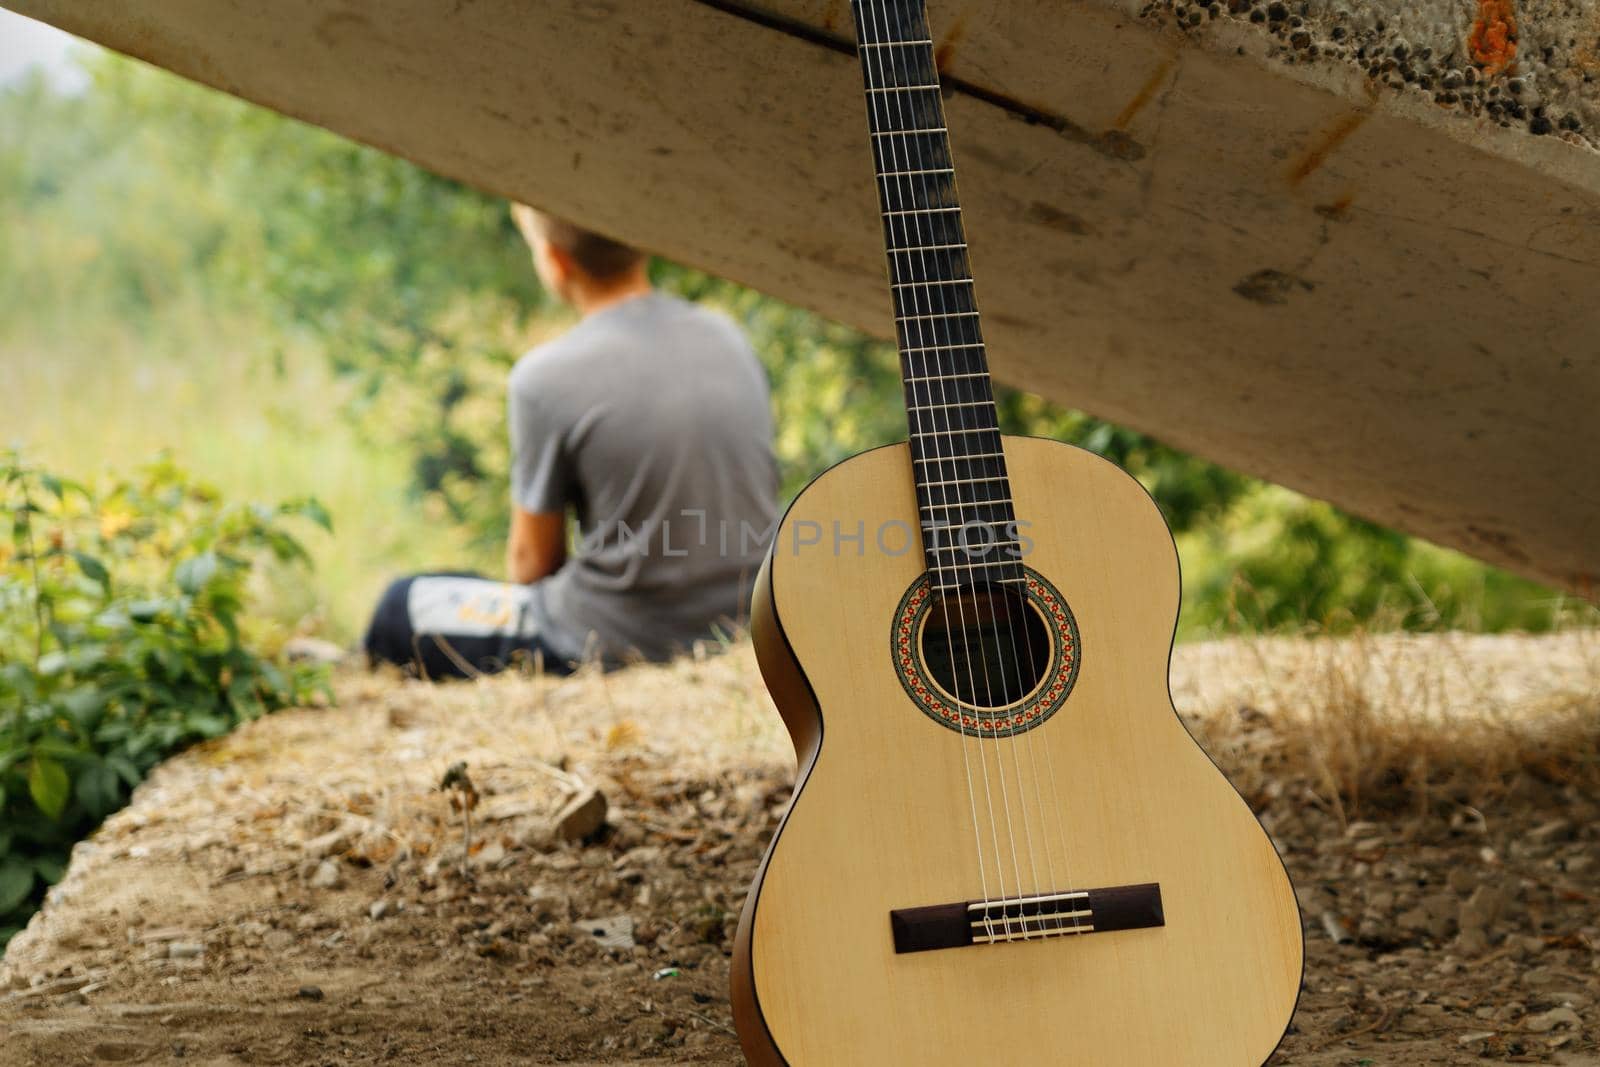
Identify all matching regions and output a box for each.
[0,58,1560,632]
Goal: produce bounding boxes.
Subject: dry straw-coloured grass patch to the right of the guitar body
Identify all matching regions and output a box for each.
[1173,630,1600,822]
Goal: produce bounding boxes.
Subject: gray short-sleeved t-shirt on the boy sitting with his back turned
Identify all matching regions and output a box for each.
[509,293,778,659]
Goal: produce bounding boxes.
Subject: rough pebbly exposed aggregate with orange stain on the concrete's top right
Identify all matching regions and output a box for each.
[1138,0,1600,147]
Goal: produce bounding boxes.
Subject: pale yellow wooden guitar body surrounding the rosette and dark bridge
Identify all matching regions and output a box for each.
[733,437,1302,1067]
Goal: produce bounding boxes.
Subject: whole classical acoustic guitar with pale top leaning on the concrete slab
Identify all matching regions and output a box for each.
[733,0,1302,1067]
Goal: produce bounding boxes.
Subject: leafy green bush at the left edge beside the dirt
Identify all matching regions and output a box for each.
[0,453,328,947]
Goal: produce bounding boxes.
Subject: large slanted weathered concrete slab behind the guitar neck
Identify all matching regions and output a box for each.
[3,0,1600,593]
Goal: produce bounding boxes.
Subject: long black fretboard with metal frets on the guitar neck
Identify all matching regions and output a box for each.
[851,0,1022,590]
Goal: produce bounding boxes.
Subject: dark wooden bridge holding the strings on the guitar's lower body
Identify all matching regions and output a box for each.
[890,881,1166,953]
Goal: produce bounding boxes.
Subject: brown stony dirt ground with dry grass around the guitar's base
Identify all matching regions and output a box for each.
[0,633,1600,1067]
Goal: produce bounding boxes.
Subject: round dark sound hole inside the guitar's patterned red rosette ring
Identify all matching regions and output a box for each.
[922,585,1050,709]
